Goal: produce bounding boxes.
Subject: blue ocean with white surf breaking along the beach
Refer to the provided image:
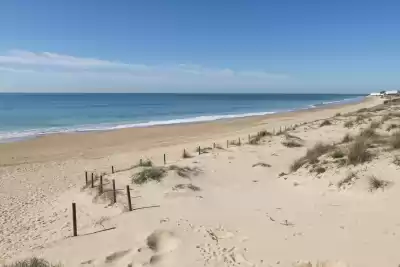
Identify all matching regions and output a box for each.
[0,93,363,142]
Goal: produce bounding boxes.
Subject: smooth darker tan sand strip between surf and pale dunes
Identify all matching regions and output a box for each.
[0,97,381,166]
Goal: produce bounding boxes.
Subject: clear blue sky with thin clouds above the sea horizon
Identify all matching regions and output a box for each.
[0,0,400,94]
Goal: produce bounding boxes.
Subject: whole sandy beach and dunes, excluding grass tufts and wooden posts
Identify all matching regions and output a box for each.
[0,98,400,267]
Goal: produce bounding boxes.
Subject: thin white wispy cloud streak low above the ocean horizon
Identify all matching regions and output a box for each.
[0,50,289,89]
